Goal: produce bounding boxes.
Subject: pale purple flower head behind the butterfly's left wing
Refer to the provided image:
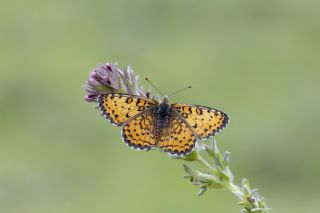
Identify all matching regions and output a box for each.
[84,63,146,102]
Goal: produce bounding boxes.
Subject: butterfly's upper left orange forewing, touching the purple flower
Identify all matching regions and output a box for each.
[98,94,158,126]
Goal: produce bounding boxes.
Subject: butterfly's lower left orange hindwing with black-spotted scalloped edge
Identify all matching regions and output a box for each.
[121,111,156,150]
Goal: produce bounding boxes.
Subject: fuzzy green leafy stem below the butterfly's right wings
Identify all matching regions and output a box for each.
[180,141,270,213]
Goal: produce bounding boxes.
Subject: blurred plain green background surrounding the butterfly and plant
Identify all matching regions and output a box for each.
[0,0,320,213]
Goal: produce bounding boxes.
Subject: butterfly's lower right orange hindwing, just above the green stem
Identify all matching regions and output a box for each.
[156,114,196,156]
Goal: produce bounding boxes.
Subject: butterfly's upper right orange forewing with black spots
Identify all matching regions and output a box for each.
[171,104,229,139]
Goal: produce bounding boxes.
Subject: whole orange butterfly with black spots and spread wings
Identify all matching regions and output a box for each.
[98,85,229,156]
